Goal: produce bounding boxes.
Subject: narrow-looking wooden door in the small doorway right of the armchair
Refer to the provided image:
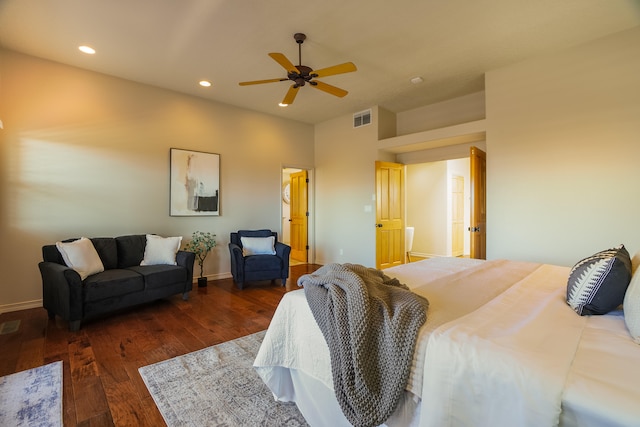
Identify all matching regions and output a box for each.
[289,170,309,262]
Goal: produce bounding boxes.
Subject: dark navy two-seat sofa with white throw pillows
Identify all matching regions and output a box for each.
[38,234,195,331]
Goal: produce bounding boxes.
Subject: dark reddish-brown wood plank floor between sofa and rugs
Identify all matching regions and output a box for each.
[0,264,319,427]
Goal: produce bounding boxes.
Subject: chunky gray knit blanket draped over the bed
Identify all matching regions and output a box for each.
[298,264,429,427]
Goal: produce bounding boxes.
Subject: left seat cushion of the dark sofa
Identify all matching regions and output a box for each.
[83,269,144,301]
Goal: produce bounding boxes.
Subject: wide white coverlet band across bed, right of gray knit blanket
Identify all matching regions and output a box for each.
[420,265,587,427]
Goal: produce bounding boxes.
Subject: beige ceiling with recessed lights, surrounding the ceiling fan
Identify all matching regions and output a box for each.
[0,0,640,123]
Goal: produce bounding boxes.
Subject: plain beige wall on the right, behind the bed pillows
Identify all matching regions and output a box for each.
[485,28,640,265]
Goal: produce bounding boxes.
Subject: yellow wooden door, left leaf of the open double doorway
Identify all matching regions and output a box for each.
[375,162,405,269]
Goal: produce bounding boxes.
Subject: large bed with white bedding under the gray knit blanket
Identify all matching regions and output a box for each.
[254,258,640,427]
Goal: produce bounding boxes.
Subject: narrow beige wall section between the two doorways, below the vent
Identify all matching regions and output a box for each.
[315,108,391,267]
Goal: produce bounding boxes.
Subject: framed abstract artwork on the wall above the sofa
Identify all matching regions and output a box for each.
[170,148,220,216]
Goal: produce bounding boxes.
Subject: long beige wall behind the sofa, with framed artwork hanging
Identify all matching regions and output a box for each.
[0,51,314,311]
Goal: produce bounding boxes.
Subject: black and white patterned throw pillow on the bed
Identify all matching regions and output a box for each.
[567,245,631,316]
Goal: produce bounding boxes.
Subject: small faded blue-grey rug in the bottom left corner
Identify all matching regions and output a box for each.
[0,362,62,427]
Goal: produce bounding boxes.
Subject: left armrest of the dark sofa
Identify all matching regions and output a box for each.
[38,261,83,322]
